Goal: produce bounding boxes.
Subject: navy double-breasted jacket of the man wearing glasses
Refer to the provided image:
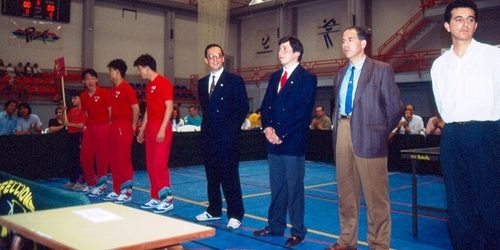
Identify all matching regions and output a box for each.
[198,71,249,152]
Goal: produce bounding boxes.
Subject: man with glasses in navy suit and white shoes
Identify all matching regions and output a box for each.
[196,44,249,229]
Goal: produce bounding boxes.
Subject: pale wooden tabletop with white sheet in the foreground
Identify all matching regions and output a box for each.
[0,202,215,249]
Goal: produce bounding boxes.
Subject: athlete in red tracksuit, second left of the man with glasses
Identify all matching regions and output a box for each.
[104,59,139,203]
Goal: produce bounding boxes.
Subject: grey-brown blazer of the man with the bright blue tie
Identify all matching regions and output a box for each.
[332,57,403,158]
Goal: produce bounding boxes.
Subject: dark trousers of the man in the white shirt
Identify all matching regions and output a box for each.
[440,121,500,250]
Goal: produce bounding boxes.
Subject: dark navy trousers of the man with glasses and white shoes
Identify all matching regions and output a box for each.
[204,147,245,221]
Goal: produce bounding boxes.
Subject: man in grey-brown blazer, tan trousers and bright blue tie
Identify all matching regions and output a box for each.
[327,26,403,250]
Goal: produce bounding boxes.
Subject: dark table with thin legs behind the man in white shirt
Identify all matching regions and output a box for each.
[401,147,447,239]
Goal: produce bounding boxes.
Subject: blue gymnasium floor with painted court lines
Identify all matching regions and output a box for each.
[36,161,452,250]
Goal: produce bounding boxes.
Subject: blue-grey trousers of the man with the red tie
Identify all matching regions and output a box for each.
[267,154,307,239]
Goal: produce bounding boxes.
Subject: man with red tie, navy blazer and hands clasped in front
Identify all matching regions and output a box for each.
[254,36,318,246]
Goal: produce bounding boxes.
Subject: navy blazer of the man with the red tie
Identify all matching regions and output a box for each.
[261,65,318,156]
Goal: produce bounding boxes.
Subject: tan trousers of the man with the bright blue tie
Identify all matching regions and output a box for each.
[336,119,391,249]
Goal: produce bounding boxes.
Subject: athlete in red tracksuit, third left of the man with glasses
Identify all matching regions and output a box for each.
[80,69,111,197]
